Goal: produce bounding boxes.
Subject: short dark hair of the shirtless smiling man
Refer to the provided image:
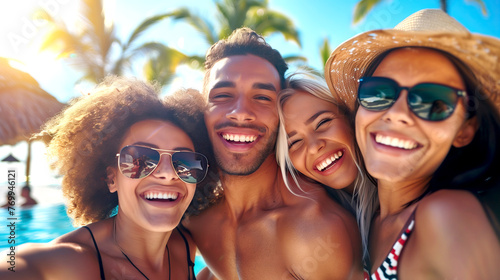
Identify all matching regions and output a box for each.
[203,27,288,94]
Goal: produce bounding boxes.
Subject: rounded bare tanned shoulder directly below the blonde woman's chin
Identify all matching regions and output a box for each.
[277,187,362,279]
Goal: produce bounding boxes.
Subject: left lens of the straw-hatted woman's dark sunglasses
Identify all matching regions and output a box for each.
[358,77,398,111]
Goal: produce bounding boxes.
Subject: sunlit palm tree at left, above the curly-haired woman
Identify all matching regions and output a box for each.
[37,0,193,86]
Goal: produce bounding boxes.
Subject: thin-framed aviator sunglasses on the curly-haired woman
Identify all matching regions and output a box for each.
[116,146,208,184]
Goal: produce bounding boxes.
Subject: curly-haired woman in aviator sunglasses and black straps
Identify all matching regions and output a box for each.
[0,77,216,279]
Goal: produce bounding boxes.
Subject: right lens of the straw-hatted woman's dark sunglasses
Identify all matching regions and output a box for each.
[408,84,458,121]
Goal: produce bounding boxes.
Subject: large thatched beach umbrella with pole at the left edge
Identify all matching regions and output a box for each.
[0,57,64,185]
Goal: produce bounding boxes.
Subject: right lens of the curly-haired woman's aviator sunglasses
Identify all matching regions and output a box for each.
[172,152,208,183]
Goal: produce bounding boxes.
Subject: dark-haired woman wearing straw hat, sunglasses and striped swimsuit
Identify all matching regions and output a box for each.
[325,10,500,279]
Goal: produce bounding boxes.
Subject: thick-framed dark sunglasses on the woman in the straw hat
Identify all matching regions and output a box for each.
[358,77,466,121]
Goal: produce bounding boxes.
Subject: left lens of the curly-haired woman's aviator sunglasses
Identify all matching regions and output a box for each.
[118,146,160,179]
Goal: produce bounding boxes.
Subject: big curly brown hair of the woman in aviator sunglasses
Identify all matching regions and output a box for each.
[39,77,222,225]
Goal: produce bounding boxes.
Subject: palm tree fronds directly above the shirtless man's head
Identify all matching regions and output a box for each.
[166,0,305,61]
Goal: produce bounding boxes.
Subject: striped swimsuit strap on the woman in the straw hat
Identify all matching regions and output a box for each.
[365,211,415,280]
